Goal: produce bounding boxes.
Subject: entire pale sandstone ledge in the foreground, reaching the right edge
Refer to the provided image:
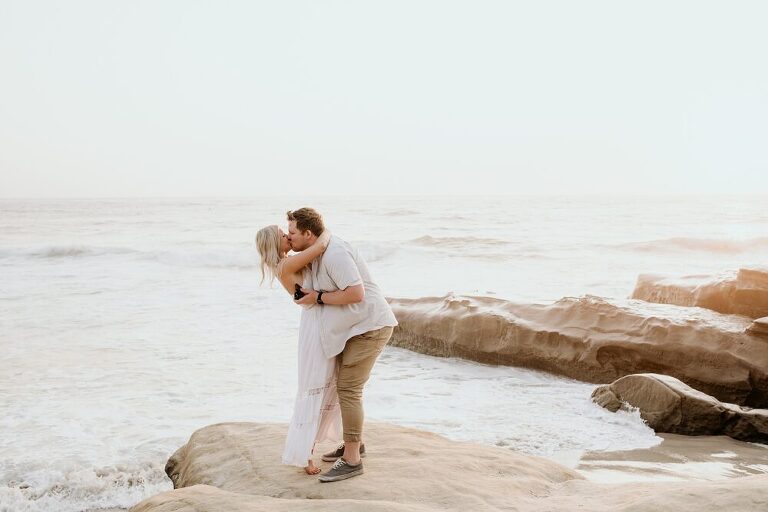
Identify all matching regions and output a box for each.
[131,423,768,512]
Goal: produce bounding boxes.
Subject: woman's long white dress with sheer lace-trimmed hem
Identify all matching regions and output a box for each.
[283,272,342,468]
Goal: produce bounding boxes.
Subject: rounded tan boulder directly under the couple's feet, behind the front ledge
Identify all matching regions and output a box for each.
[133,423,581,512]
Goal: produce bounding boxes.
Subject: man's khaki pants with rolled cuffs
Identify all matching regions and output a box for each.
[336,327,394,442]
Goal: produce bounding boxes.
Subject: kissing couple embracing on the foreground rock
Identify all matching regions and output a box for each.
[256,208,397,482]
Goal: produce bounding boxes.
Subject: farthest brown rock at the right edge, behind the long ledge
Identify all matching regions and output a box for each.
[632,267,768,318]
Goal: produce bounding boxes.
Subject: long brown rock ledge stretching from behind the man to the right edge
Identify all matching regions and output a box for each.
[389,295,768,407]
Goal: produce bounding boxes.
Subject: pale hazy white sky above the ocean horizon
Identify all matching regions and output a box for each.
[0,0,768,197]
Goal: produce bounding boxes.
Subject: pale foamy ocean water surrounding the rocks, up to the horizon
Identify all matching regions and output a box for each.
[0,196,768,512]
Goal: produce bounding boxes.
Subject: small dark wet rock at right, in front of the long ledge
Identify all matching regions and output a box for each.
[592,373,768,443]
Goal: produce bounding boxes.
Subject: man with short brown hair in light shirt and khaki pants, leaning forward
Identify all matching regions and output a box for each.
[288,208,397,482]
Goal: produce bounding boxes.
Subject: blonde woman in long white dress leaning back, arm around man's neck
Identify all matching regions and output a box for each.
[256,225,342,475]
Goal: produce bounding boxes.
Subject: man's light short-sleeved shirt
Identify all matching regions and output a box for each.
[309,236,397,358]
